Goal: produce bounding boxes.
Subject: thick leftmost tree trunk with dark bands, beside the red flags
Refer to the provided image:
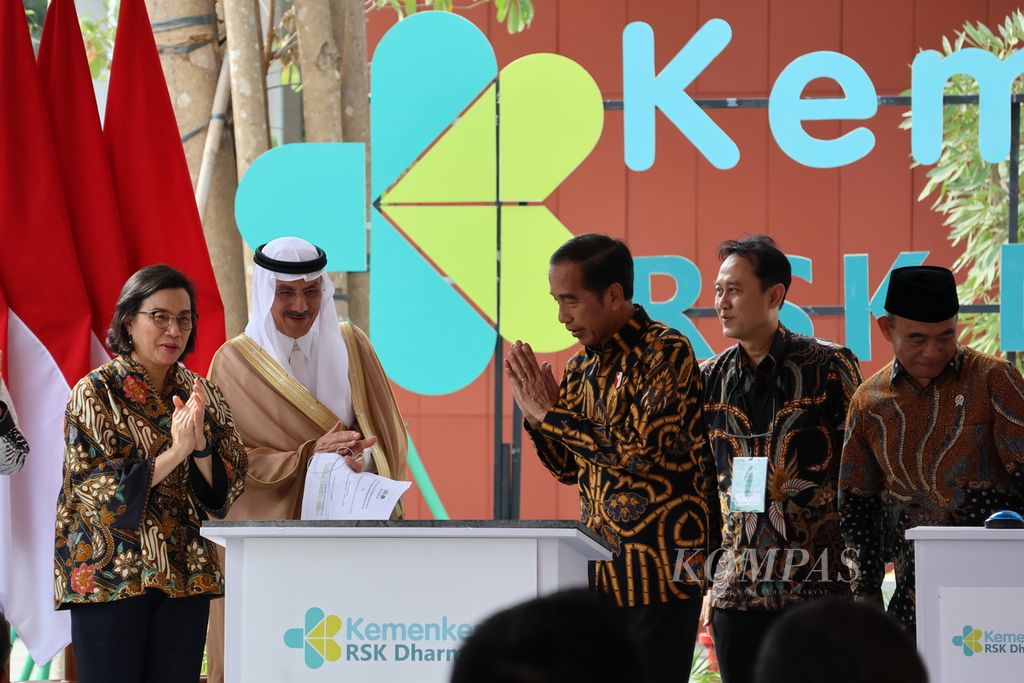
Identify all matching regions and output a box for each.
[146,0,247,337]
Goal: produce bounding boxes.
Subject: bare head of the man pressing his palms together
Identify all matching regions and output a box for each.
[548,232,634,347]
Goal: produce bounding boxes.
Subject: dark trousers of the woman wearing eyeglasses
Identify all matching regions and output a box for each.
[71,589,210,683]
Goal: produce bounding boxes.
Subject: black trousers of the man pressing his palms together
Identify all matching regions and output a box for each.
[622,596,700,683]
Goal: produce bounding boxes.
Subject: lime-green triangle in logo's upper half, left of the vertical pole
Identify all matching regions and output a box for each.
[381,84,498,204]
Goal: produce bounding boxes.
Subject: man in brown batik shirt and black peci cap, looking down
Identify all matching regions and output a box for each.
[839,266,1024,635]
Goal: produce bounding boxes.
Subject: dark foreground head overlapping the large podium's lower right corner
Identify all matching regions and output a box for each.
[452,590,645,683]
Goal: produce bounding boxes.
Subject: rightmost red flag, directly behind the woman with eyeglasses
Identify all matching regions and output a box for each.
[103,0,224,375]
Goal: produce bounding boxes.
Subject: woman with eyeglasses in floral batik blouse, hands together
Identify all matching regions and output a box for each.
[54,265,247,683]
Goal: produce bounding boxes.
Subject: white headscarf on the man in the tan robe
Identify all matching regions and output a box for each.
[246,238,355,426]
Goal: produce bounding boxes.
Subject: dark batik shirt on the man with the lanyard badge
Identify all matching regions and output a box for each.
[701,326,861,610]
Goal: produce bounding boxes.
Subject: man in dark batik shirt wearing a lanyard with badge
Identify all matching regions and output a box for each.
[701,234,861,683]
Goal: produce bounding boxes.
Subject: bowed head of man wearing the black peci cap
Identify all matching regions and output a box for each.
[879,265,959,387]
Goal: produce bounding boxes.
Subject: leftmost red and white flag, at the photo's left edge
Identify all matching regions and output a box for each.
[0,2,91,661]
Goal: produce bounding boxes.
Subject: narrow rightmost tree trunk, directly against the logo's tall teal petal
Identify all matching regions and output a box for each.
[331,0,372,334]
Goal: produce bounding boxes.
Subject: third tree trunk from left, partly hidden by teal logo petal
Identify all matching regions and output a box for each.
[295,0,349,319]
